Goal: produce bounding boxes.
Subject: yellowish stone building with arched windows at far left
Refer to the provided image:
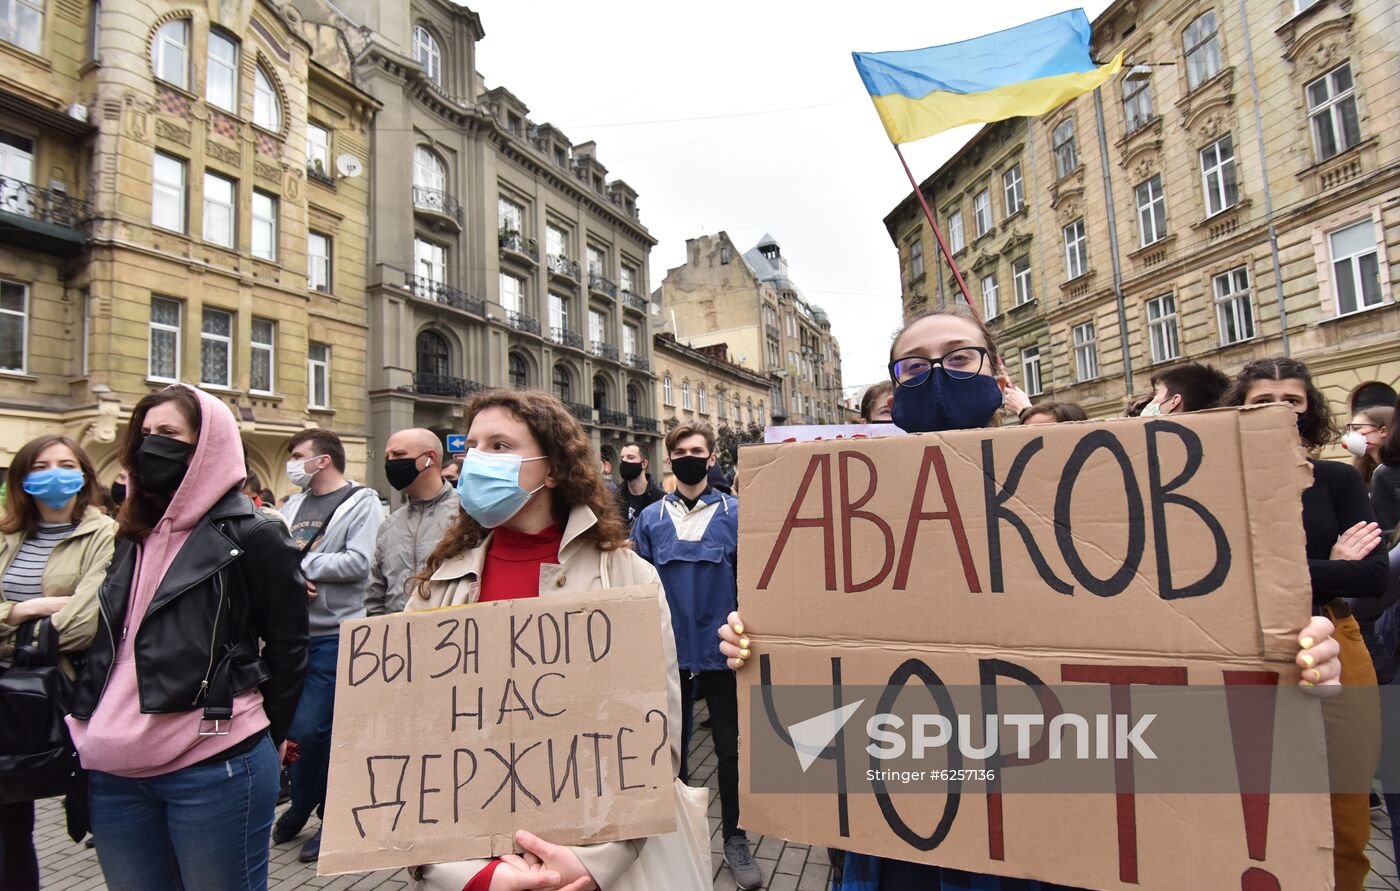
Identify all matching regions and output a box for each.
[0,0,375,490]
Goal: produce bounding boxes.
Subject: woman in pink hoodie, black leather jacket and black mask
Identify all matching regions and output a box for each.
[69,384,307,891]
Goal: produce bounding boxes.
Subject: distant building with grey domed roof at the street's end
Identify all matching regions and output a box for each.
[659,231,841,424]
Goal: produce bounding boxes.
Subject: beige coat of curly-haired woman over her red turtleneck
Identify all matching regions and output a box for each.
[403,507,710,891]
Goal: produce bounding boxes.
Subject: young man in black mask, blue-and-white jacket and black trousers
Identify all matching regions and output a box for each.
[631,423,763,888]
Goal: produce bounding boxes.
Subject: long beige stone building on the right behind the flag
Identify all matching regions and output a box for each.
[885,0,1400,422]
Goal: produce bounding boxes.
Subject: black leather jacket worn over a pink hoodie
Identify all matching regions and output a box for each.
[73,490,307,744]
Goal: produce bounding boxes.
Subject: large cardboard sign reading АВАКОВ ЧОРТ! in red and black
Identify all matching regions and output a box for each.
[739,406,1333,891]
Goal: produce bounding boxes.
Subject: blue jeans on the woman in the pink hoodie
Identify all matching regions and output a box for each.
[88,734,277,891]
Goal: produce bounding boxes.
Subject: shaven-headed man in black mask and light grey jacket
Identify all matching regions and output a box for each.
[364,427,461,615]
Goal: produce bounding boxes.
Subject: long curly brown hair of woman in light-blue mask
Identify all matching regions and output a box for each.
[409,389,627,600]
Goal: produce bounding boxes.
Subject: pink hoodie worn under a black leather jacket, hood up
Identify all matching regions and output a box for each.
[69,384,267,779]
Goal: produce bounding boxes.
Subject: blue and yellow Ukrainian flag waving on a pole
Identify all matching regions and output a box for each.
[851,10,1123,144]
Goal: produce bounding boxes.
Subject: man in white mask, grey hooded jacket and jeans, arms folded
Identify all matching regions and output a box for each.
[272,429,384,863]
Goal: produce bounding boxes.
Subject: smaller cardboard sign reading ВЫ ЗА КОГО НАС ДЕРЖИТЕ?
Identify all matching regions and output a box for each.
[318,586,679,874]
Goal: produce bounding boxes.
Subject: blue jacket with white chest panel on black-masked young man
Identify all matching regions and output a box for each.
[631,490,739,671]
